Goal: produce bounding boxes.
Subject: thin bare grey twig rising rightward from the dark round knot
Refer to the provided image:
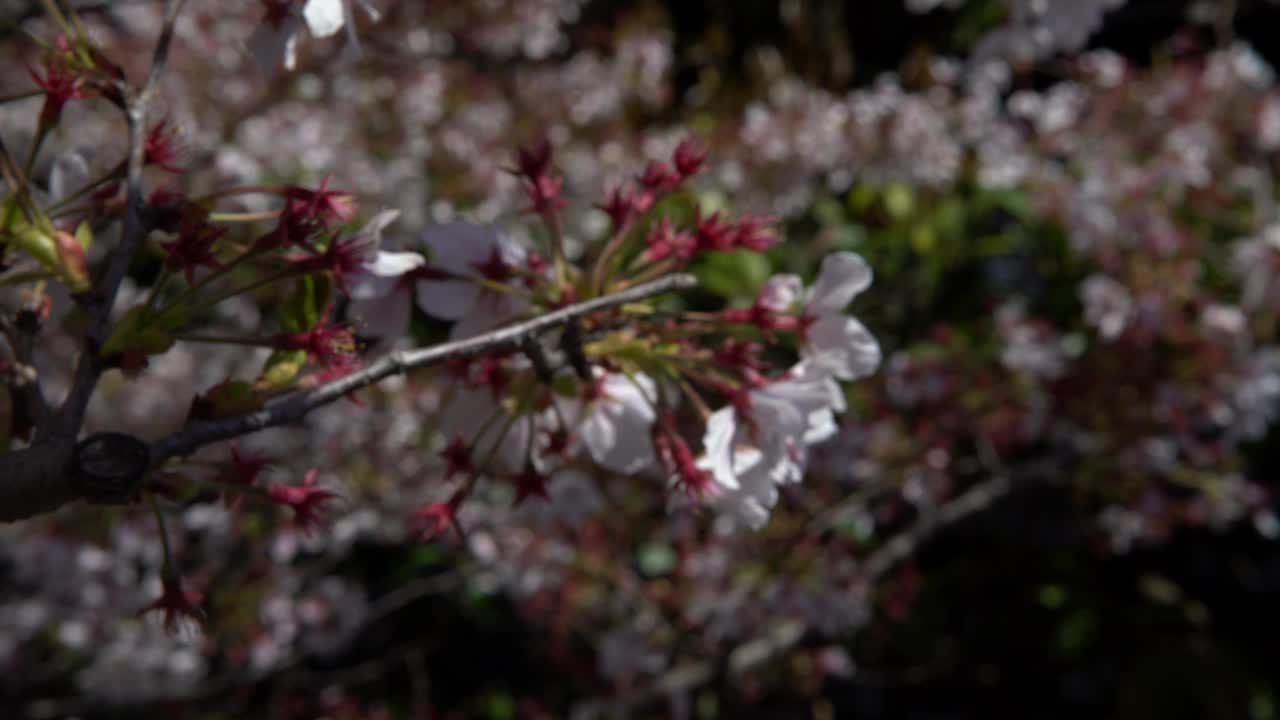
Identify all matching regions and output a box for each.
[151,274,698,465]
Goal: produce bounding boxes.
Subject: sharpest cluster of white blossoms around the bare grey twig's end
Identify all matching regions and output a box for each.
[347,207,881,528]
